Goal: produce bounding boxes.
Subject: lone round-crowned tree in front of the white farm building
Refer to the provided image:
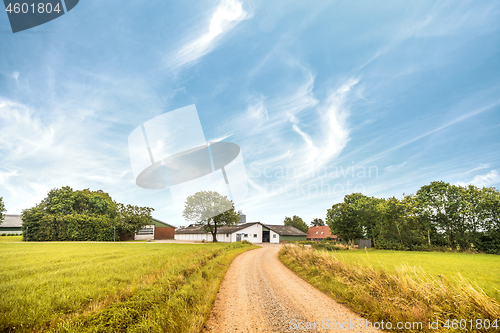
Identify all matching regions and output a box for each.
[182,191,240,242]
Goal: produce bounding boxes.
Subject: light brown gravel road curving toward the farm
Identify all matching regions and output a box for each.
[204,245,380,333]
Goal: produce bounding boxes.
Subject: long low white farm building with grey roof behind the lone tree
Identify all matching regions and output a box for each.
[175,222,307,243]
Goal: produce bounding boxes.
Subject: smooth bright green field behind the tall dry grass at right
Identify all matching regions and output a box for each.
[331,249,500,301]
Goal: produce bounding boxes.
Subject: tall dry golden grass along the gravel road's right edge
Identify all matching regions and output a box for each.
[279,245,500,332]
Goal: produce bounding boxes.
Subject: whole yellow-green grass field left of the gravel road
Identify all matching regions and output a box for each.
[0,240,256,332]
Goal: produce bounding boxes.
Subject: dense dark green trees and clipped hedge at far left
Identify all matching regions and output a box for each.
[21,187,152,241]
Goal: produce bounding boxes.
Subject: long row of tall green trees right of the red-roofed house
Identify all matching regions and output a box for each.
[326,181,500,254]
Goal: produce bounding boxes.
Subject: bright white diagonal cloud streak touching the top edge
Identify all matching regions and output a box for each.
[168,0,250,68]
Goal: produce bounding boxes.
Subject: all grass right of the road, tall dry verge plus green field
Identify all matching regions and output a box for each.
[279,245,500,332]
